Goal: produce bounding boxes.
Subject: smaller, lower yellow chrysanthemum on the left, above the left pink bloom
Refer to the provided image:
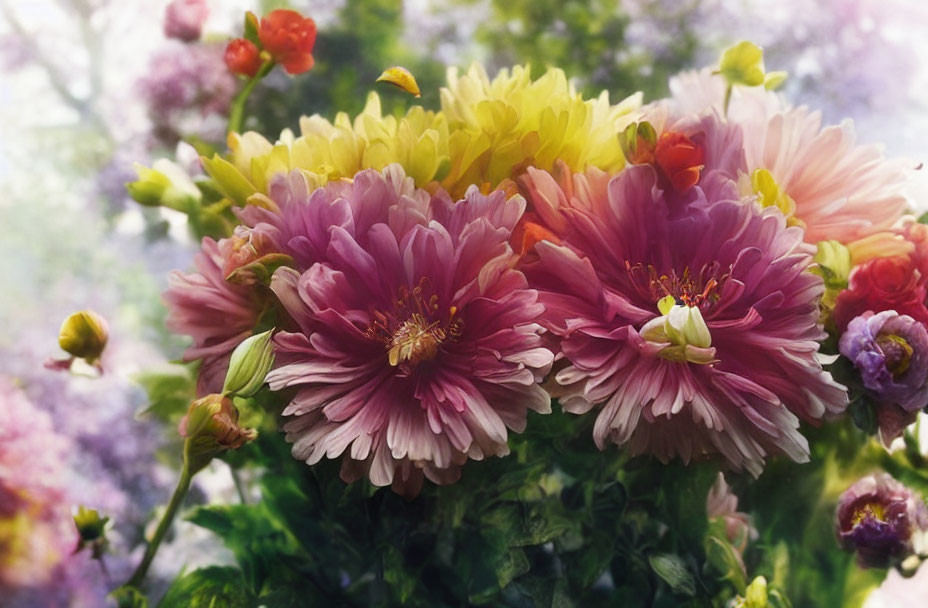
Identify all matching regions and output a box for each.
[204,93,449,204]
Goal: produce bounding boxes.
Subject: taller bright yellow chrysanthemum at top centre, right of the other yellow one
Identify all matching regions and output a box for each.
[441,64,641,195]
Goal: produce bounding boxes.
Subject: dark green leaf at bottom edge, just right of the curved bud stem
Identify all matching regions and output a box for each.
[158,566,256,608]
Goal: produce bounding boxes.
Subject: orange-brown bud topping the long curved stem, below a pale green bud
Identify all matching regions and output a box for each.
[177,394,258,471]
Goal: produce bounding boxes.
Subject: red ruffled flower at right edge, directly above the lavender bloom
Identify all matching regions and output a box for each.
[833,256,928,333]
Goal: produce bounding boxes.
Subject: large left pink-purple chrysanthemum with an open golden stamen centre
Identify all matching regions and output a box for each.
[260,166,554,494]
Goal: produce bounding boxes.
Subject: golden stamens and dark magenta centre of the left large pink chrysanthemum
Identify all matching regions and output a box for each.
[367,278,463,366]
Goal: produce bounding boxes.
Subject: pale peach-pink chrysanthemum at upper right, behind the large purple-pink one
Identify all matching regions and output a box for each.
[658,70,909,243]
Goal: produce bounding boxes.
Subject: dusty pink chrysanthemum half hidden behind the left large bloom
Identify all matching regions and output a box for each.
[164,231,264,395]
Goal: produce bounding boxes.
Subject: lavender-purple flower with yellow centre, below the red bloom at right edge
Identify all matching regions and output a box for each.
[839,310,928,412]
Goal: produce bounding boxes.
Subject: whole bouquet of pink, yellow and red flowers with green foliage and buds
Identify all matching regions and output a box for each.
[12,5,928,608]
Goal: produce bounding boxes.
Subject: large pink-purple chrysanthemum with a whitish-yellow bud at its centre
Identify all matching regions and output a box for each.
[524,166,847,475]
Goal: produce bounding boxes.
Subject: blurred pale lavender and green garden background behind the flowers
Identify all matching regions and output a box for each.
[0,0,928,606]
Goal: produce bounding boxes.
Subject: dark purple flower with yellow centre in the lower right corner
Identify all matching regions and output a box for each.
[837,473,928,568]
